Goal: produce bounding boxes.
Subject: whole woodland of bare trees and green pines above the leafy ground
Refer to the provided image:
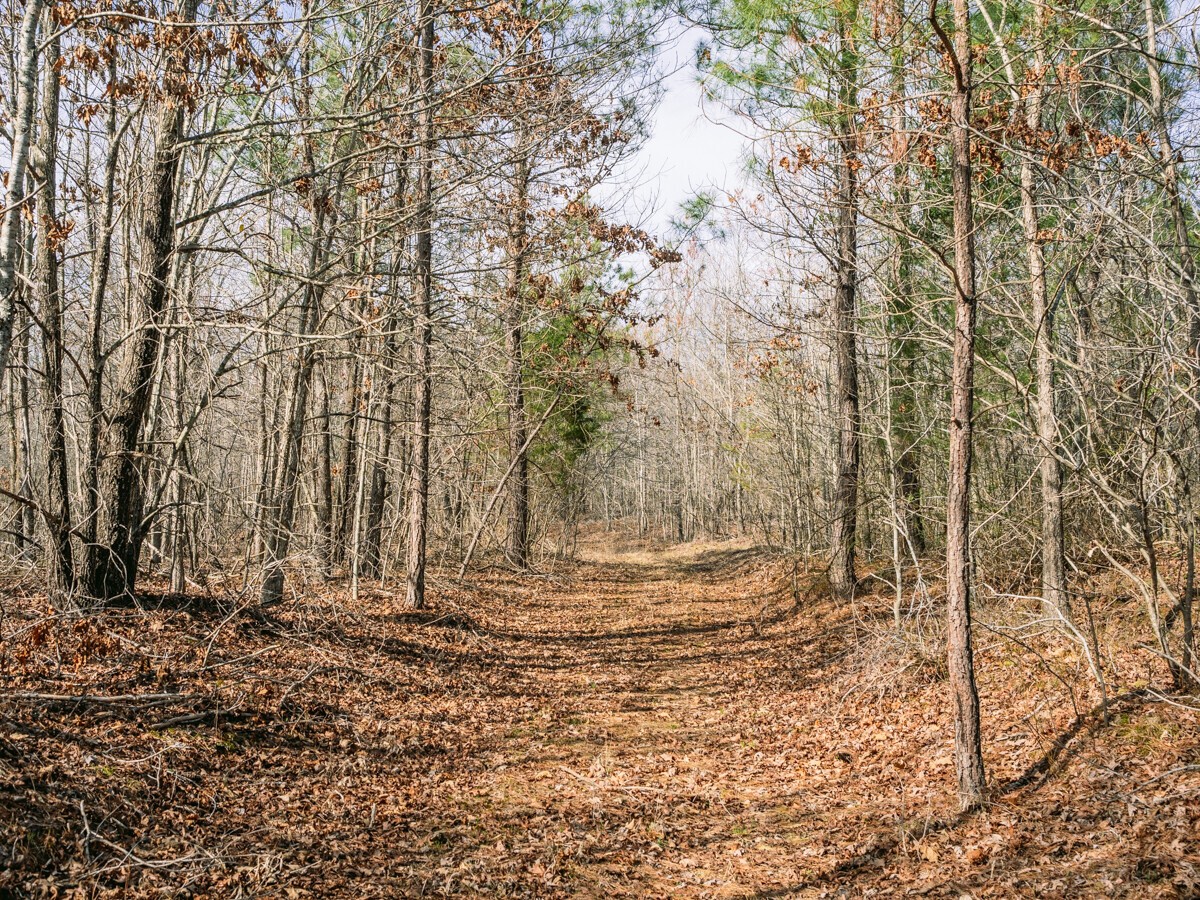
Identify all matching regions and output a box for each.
[0,0,1200,890]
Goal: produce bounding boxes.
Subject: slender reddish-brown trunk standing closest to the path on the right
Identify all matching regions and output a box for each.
[930,0,985,810]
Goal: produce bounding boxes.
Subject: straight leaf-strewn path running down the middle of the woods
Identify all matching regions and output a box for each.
[388,540,836,896]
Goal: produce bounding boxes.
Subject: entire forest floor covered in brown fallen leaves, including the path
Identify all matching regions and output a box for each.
[0,539,1200,899]
